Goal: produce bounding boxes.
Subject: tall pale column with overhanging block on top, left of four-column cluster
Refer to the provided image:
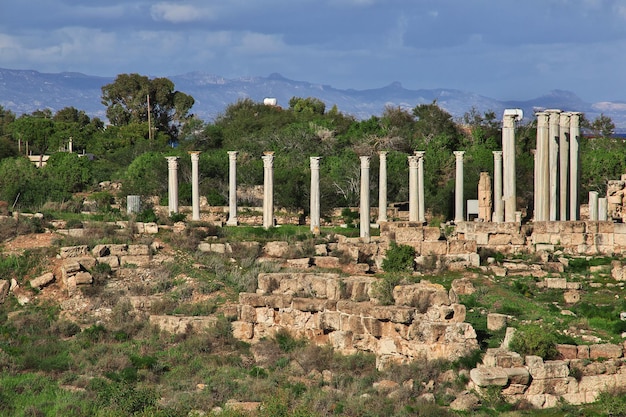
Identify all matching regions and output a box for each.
[502,109,521,222]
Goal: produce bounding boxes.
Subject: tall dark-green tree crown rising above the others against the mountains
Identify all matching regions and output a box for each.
[102,74,194,140]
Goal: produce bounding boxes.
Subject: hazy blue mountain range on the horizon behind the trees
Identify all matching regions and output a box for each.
[0,68,626,131]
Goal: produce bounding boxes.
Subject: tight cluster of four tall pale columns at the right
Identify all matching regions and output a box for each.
[535,109,580,221]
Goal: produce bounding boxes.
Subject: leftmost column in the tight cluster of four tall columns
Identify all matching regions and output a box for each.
[535,112,550,222]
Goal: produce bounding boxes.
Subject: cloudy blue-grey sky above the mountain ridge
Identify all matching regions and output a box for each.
[0,0,626,102]
